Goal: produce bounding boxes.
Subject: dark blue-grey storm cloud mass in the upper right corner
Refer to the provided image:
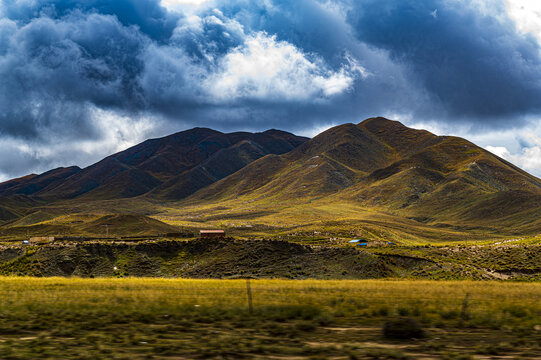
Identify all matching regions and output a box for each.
[348,0,541,120]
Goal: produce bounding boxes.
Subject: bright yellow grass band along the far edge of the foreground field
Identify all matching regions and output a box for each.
[0,277,541,320]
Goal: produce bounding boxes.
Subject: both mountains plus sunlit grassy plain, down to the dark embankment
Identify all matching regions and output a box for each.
[0,118,541,245]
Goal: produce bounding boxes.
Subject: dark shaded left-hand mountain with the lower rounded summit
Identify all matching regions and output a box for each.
[0,128,307,201]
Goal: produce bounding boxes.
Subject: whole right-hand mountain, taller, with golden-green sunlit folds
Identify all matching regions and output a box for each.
[188,118,541,230]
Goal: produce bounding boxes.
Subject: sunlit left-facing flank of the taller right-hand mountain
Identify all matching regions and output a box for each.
[186,119,434,199]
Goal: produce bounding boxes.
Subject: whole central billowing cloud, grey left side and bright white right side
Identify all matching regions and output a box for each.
[139,10,362,105]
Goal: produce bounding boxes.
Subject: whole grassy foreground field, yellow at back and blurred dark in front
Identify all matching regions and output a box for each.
[0,277,541,359]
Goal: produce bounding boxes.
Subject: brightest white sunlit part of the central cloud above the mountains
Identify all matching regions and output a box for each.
[206,32,367,101]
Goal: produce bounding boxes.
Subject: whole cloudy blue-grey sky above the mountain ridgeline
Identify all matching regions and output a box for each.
[0,0,541,181]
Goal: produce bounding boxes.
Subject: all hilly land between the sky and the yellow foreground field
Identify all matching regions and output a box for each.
[0,118,541,279]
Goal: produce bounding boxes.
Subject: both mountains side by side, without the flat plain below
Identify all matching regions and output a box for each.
[0,117,541,242]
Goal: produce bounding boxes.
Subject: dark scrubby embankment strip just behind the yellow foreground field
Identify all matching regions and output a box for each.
[0,239,541,280]
